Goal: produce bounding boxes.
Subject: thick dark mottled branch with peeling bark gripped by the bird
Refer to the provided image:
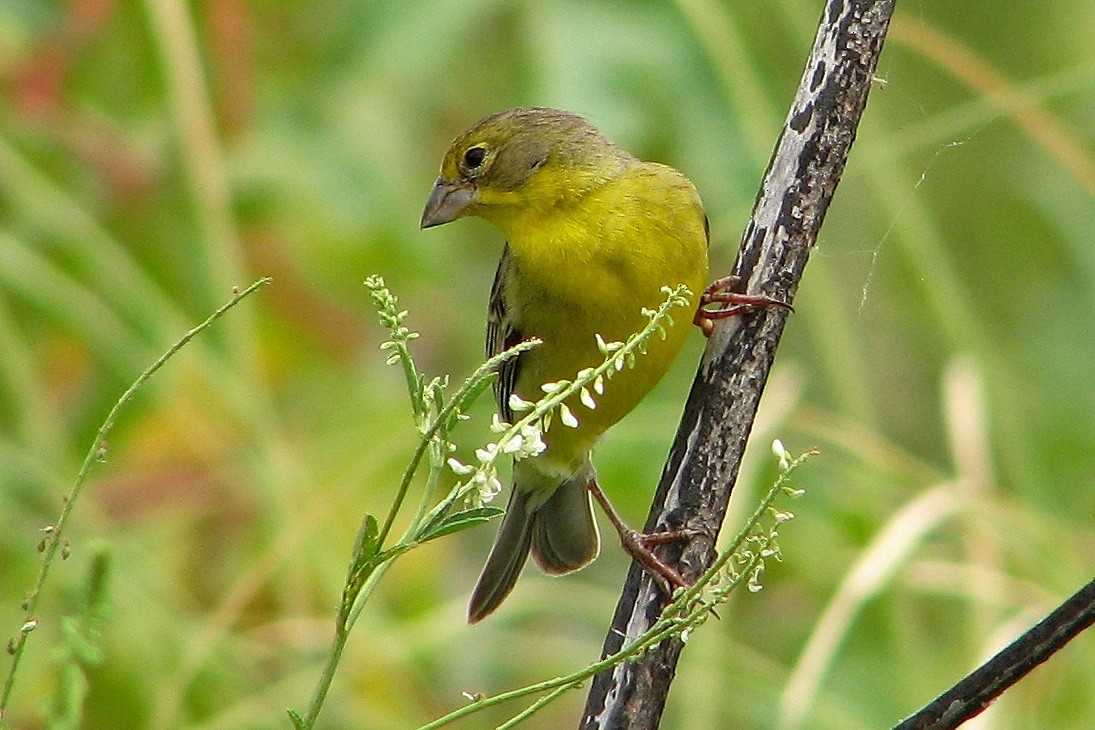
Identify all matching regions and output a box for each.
[581,0,895,730]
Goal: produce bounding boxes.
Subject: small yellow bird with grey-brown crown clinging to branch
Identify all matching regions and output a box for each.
[422,108,769,623]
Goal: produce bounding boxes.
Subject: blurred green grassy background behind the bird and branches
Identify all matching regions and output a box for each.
[0,0,1095,729]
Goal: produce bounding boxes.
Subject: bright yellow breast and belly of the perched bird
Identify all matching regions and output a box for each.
[503,165,707,473]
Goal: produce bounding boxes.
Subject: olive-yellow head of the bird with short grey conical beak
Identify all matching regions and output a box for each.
[422,107,634,231]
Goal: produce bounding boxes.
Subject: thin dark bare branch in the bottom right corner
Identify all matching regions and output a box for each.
[895,579,1095,730]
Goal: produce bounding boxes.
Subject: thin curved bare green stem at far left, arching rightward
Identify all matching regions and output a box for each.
[0,277,270,718]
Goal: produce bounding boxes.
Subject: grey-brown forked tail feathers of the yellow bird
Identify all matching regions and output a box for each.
[468,472,600,624]
